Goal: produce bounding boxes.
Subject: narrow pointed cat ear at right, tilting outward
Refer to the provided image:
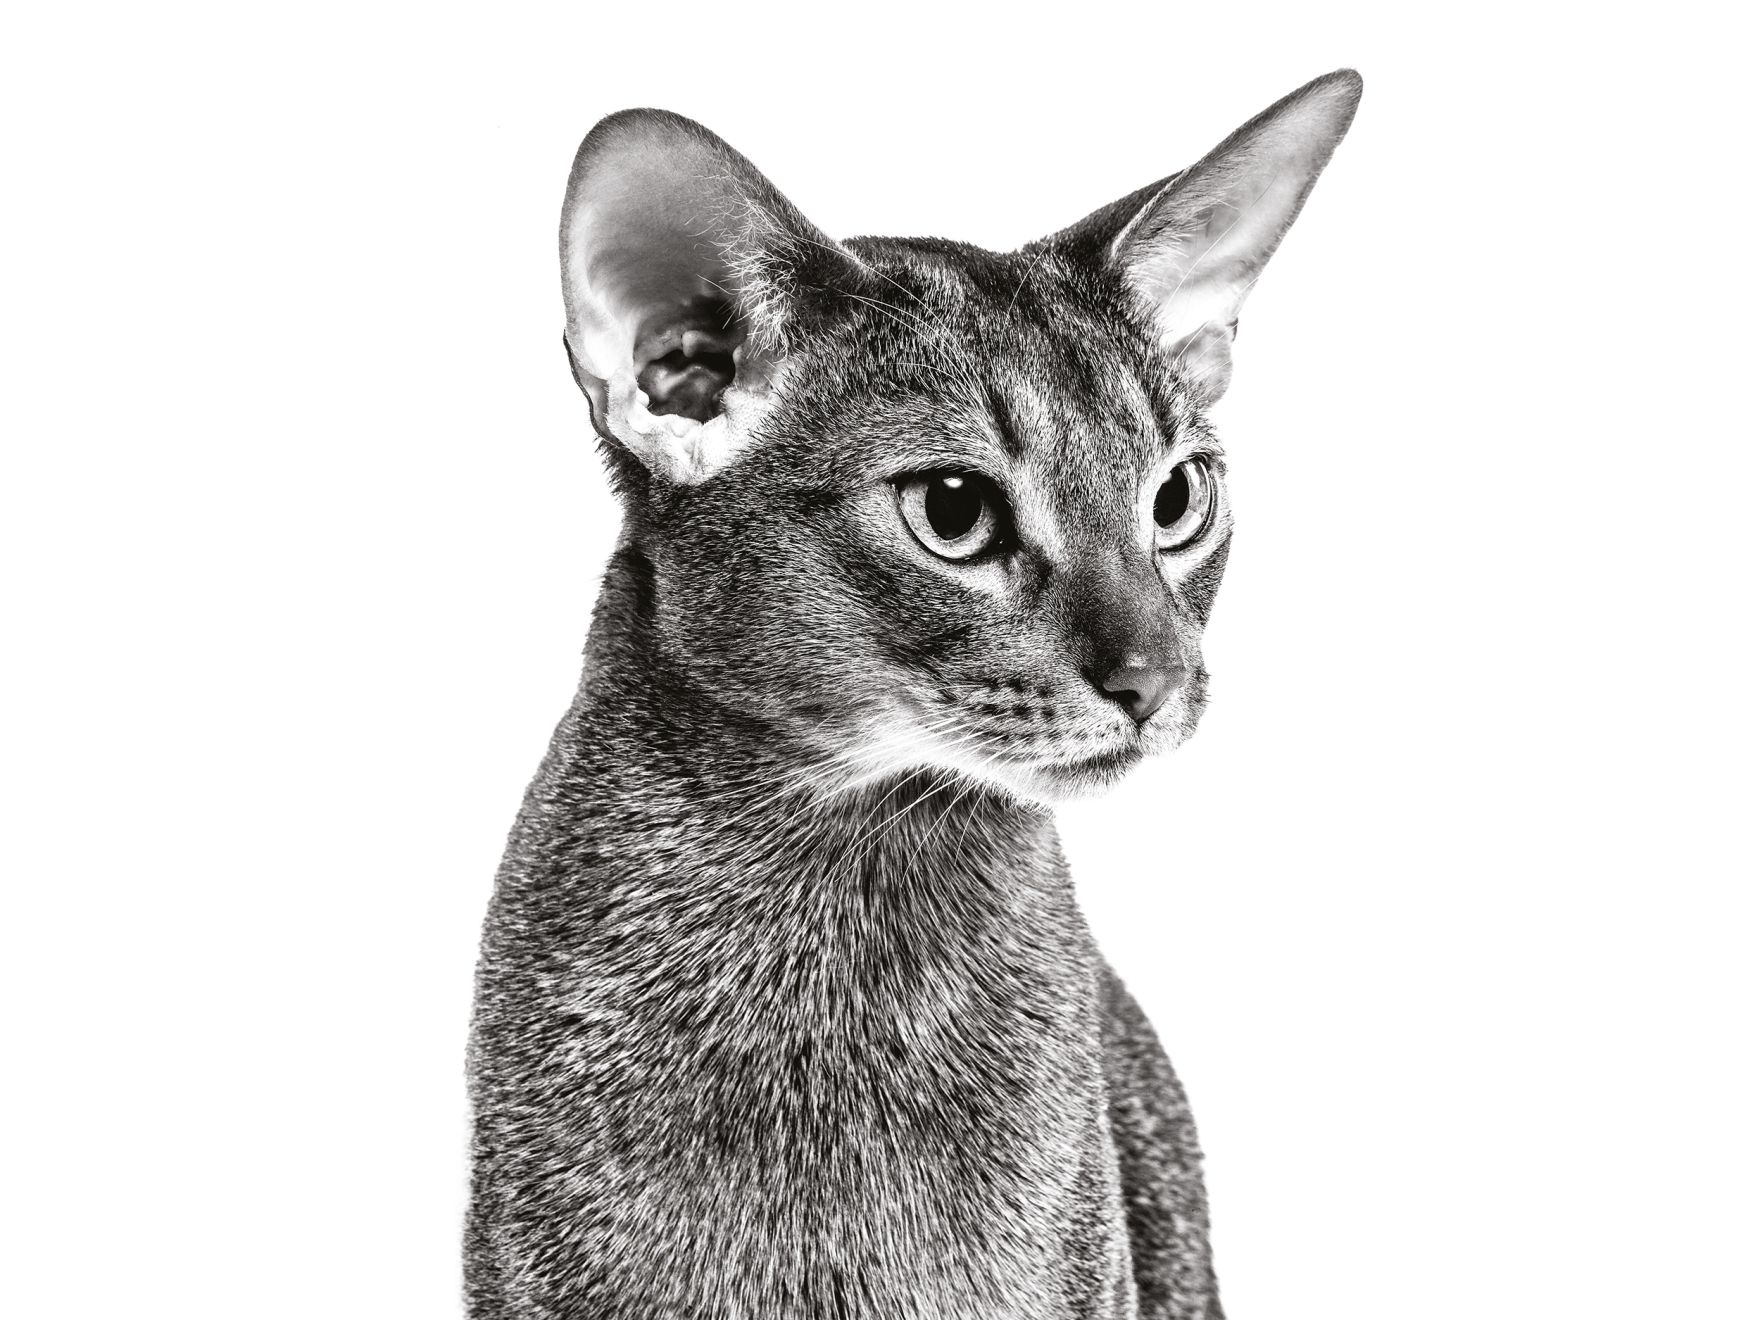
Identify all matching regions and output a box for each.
[1052,69,1362,400]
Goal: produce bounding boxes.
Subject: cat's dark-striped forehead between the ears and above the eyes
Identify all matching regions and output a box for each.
[827,239,1190,514]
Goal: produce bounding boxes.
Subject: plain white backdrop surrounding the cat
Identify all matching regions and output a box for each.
[0,4,1760,1320]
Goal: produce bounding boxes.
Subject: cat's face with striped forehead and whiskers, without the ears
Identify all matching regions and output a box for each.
[644,239,1228,799]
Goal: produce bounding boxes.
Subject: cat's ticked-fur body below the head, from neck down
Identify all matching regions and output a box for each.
[473,584,1209,1320]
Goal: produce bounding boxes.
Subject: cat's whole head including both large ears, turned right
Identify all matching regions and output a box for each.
[561,70,1362,801]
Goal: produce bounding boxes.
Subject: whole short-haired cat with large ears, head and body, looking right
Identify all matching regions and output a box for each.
[465,70,1362,1320]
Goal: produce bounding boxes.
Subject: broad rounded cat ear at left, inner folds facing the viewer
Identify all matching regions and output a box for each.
[561,109,861,484]
